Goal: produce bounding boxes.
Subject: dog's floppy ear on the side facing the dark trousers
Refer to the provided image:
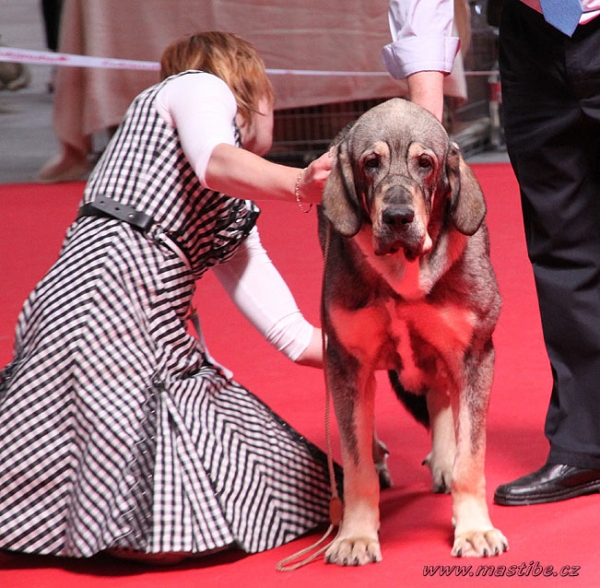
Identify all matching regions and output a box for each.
[446,143,486,236]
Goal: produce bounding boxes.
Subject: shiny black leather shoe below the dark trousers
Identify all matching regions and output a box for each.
[494,464,600,506]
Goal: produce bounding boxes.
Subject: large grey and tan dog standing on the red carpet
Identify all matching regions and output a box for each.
[319,99,507,565]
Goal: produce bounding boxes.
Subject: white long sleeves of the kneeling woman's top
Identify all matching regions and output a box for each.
[156,73,314,361]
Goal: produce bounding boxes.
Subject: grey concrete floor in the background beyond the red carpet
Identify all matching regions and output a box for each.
[0,0,507,184]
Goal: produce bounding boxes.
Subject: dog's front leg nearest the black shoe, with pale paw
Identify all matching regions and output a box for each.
[452,349,508,557]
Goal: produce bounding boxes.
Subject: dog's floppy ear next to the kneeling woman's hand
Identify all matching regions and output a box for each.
[323,140,360,237]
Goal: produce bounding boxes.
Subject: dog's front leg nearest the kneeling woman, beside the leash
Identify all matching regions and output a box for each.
[325,362,381,565]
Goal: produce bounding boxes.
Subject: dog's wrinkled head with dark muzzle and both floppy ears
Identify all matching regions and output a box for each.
[323,98,485,260]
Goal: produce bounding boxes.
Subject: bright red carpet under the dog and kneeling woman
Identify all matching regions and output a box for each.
[0,164,600,588]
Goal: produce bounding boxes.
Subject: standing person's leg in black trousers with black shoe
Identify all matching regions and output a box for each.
[495,1,600,505]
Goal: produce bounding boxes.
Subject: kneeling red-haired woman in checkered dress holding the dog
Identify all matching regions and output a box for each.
[0,32,338,559]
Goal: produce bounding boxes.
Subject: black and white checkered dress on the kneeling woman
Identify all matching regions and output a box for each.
[0,74,329,557]
